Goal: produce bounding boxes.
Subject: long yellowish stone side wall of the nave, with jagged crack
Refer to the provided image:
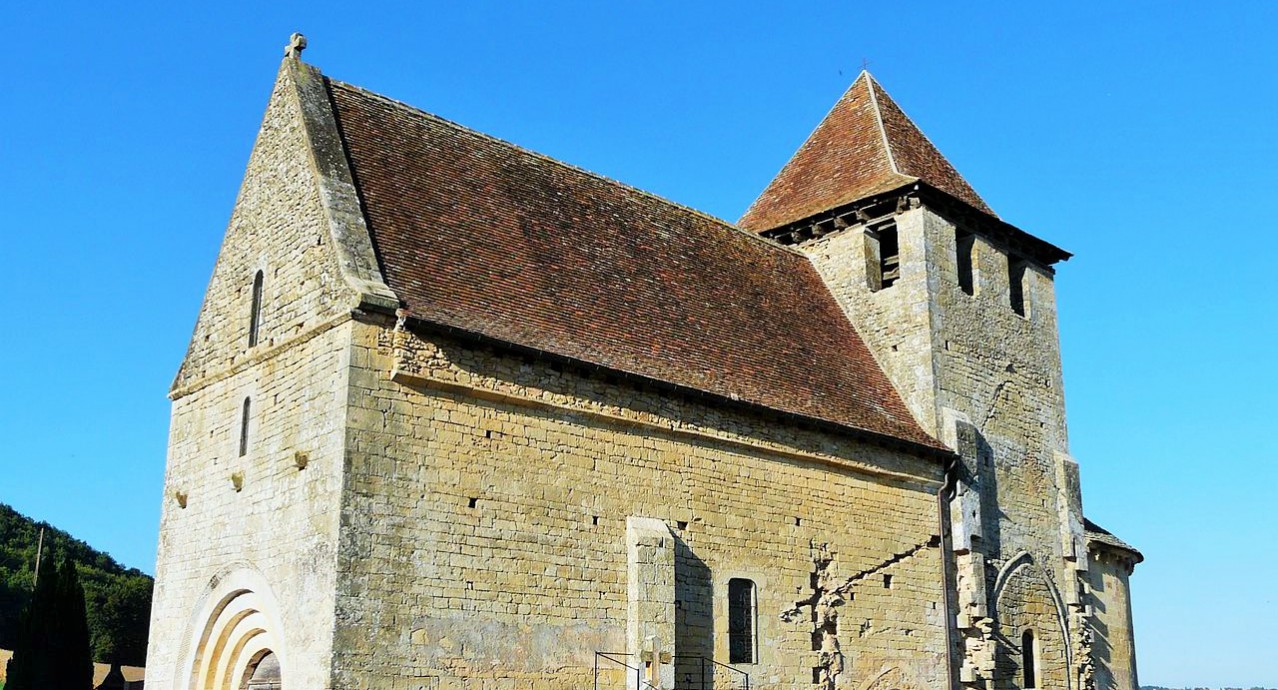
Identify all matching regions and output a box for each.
[334,323,944,690]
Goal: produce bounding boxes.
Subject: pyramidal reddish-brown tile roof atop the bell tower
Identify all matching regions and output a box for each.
[737,72,997,233]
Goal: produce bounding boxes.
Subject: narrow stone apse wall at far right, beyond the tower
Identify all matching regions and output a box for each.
[1089,547,1140,690]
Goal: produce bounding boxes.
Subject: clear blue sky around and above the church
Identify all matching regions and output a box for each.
[0,1,1278,686]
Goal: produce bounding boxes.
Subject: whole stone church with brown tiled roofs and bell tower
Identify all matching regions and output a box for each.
[147,36,1141,690]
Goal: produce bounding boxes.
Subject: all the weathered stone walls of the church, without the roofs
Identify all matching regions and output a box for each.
[147,49,1136,690]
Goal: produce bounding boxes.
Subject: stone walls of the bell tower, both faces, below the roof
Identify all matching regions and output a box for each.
[800,204,1086,687]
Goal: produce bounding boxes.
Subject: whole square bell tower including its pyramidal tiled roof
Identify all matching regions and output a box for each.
[739,72,1091,689]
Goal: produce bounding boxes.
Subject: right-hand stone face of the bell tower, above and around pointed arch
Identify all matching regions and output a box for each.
[919,210,1086,687]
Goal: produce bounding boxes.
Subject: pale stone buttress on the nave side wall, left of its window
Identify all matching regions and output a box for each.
[626,515,675,690]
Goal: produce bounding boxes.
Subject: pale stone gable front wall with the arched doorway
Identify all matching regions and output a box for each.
[147,63,355,690]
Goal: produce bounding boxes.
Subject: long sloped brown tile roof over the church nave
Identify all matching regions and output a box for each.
[328,81,942,449]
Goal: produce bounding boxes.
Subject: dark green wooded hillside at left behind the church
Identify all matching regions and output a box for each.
[0,503,153,666]
